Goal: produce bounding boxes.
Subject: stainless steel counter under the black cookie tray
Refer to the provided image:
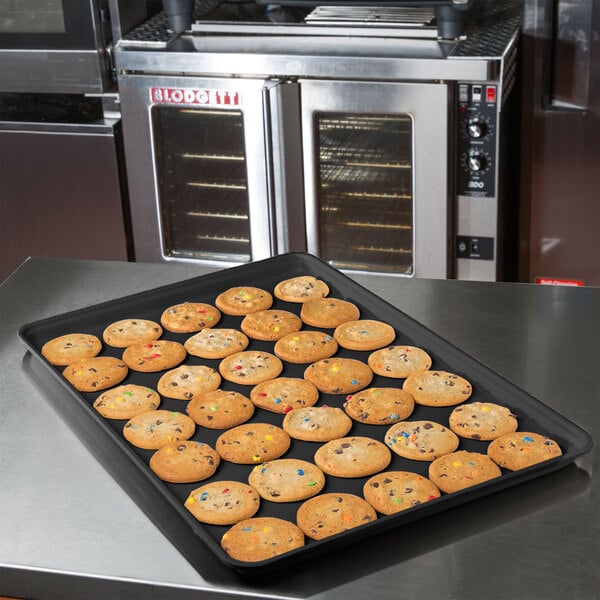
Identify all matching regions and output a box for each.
[0,259,600,600]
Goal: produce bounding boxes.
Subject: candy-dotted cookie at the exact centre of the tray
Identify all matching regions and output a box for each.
[250,377,319,414]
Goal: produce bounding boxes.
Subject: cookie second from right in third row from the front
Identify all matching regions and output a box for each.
[344,388,415,425]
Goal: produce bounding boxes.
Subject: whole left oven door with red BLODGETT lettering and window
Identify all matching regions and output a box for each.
[119,75,286,266]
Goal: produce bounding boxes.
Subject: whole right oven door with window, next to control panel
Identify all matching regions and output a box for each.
[300,81,450,278]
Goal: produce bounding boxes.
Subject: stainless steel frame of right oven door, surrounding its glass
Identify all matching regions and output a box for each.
[300,80,450,278]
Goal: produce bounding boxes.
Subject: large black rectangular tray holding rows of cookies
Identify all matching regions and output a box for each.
[18,253,593,574]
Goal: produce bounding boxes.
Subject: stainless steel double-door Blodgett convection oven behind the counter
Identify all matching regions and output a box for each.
[116,0,520,280]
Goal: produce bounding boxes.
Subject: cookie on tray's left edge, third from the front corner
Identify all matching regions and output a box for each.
[150,440,221,483]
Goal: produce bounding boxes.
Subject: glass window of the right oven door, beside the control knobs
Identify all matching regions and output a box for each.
[315,112,414,275]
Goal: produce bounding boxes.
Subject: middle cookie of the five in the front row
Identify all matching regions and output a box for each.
[363,471,441,515]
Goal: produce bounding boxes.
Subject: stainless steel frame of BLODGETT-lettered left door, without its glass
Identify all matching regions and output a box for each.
[119,75,278,266]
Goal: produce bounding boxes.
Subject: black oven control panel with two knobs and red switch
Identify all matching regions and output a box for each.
[457,83,498,198]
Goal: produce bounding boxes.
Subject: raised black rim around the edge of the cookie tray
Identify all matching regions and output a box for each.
[17,252,594,574]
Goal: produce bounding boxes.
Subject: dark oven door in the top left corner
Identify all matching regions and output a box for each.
[0,0,111,93]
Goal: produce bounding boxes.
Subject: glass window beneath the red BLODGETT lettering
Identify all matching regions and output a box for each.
[152,106,250,262]
